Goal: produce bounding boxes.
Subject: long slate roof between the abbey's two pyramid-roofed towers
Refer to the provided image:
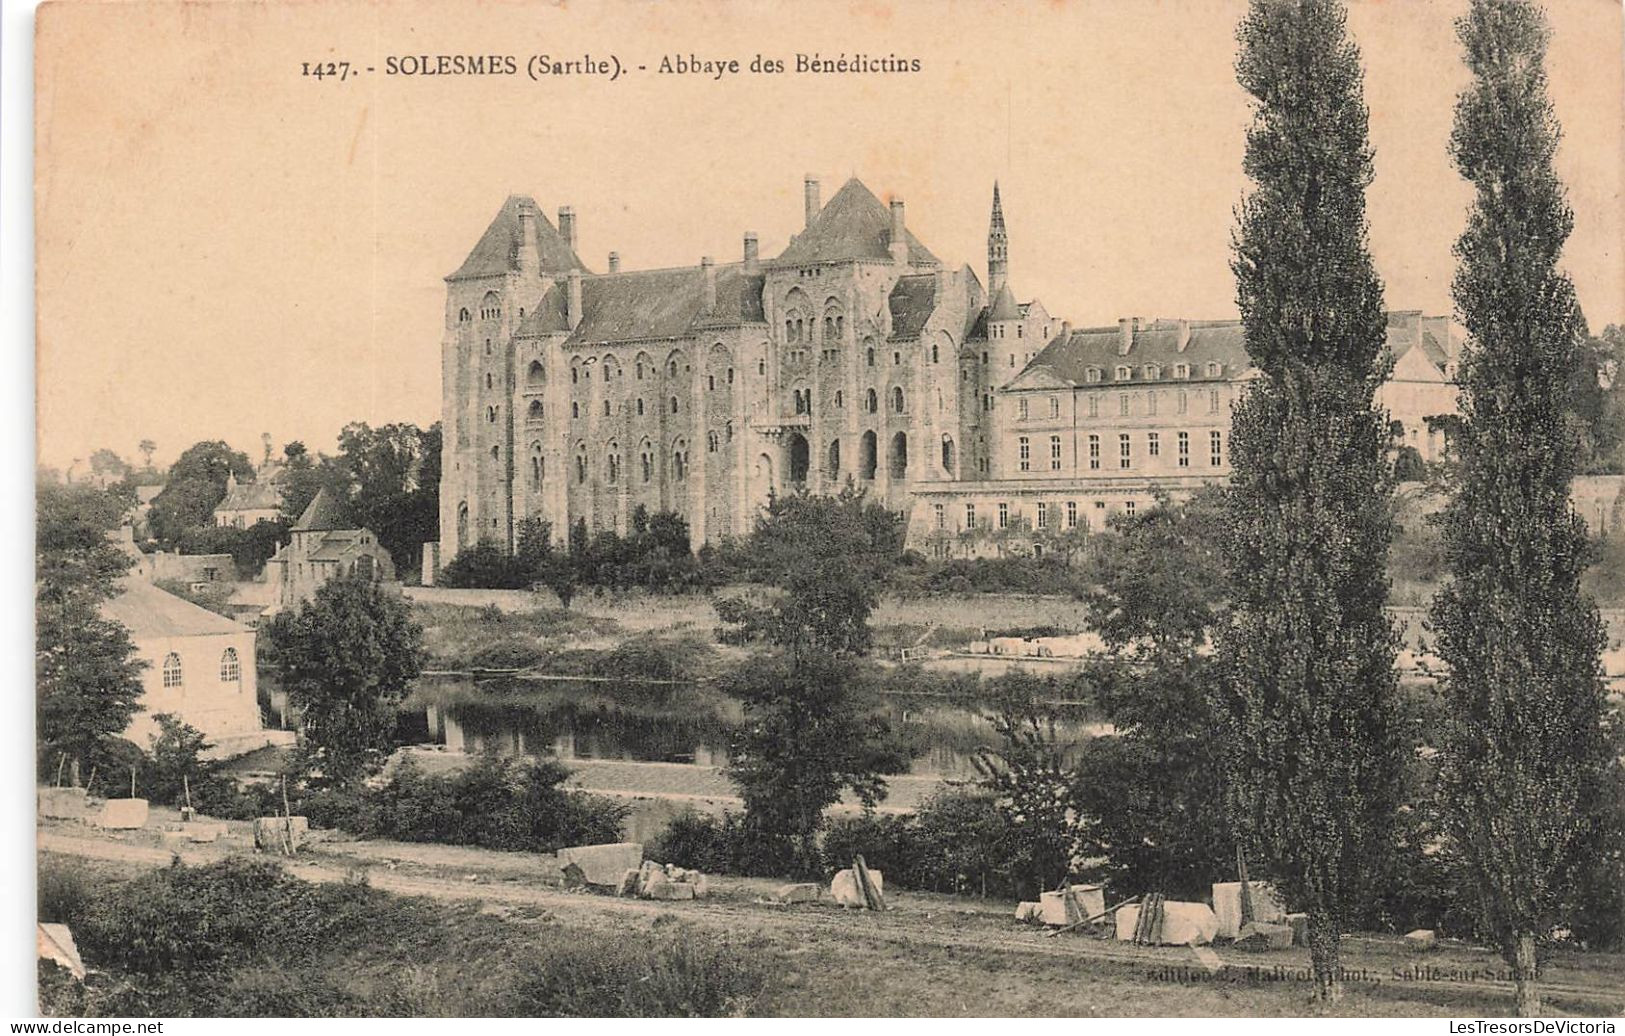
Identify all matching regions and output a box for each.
[518,263,765,344]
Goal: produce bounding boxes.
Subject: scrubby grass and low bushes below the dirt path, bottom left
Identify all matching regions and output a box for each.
[41,857,769,1017]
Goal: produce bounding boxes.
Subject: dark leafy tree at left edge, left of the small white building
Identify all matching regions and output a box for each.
[34,484,145,782]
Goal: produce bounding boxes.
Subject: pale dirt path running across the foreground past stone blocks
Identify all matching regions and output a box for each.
[37,825,1625,1013]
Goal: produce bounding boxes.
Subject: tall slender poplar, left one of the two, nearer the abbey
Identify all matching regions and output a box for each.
[1216,0,1401,1000]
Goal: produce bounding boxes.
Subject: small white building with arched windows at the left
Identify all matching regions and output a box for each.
[101,578,268,758]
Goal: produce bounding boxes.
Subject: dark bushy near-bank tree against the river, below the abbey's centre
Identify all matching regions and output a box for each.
[723,653,902,877]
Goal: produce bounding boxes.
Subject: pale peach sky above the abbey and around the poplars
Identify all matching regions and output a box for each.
[36,0,1625,468]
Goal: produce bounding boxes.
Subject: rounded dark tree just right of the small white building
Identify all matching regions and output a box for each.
[268,576,423,786]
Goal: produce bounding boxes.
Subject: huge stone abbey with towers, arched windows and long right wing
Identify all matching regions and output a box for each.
[429,175,1461,563]
